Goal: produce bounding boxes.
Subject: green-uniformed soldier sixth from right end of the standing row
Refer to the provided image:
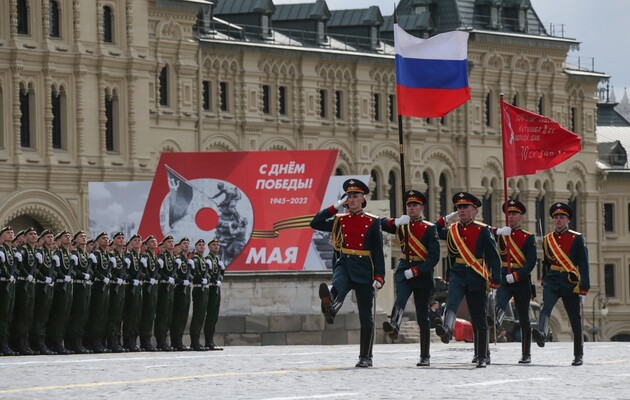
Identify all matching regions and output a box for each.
[123,234,144,352]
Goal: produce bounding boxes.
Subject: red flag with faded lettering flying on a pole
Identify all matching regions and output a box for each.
[501,99,582,178]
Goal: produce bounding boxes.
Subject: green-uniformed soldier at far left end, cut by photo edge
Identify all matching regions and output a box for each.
[0,226,18,356]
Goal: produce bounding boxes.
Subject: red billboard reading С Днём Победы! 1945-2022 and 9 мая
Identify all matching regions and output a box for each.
[138,150,338,271]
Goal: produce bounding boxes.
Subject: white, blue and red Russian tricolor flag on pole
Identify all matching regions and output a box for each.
[394,24,470,118]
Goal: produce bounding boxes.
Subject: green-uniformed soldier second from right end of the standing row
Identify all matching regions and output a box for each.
[190,239,208,351]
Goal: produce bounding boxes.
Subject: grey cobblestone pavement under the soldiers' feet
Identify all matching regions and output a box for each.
[0,342,630,400]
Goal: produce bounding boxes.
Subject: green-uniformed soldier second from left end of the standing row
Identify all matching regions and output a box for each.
[11,227,39,356]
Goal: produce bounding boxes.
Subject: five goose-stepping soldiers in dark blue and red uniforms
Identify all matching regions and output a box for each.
[311,179,590,368]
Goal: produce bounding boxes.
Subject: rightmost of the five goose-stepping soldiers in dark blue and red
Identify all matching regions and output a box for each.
[533,203,591,366]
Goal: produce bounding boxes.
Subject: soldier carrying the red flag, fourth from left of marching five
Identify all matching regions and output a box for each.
[495,200,536,364]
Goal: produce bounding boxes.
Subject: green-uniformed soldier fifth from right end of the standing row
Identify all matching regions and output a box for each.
[140,235,160,351]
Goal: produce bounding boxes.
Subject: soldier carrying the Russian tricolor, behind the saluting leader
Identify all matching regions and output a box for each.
[381,190,440,367]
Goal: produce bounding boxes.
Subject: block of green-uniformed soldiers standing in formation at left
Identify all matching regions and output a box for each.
[0,226,225,356]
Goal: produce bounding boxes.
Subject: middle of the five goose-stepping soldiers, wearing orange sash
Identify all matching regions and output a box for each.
[435,192,501,368]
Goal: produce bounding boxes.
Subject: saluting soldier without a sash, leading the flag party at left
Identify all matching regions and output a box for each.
[311,179,385,368]
